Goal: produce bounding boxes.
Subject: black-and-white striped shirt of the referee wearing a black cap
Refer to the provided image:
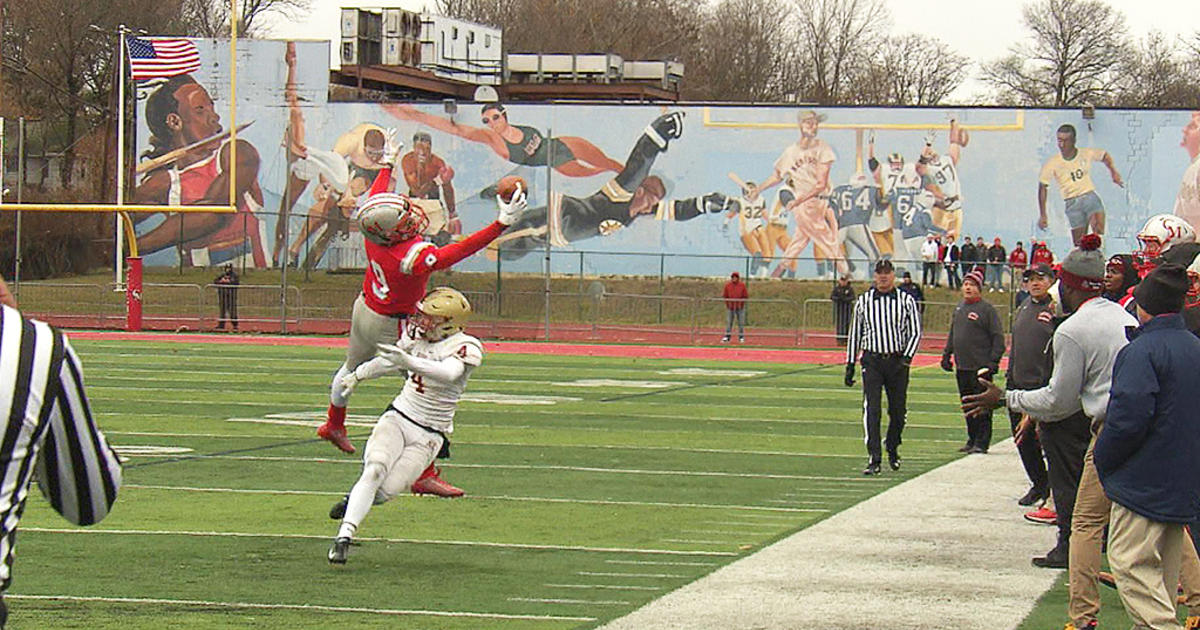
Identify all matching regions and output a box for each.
[846,287,920,364]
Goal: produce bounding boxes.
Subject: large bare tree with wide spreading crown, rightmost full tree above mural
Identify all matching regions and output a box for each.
[983,0,1128,107]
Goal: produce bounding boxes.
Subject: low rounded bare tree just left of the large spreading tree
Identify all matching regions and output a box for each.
[844,34,971,106]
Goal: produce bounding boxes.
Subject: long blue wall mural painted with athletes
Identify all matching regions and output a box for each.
[136,40,1200,276]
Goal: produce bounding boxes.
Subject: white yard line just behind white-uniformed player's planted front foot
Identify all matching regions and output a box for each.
[22,527,737,556]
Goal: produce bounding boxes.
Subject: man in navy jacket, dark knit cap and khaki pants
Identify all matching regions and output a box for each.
[1094,264,1200,628]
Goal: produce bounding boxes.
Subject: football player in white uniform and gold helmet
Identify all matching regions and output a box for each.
[329,287,484,564]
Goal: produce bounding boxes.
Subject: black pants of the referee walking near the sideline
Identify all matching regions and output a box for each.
[863,352,908,463]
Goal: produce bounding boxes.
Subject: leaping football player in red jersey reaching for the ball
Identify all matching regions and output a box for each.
[317,131,526,496]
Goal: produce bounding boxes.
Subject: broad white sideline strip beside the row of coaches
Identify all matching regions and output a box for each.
[602,440,1060,630]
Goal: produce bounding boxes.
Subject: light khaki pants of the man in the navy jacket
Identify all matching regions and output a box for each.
[1109,503,1194,630]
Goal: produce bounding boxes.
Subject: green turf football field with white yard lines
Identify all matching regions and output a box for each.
[2,341,1142,630]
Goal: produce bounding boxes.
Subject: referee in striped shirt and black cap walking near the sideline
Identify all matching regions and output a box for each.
[846,260,920,475]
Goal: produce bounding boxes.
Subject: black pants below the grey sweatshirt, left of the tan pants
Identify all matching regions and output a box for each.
[1038,410,1092,548]
